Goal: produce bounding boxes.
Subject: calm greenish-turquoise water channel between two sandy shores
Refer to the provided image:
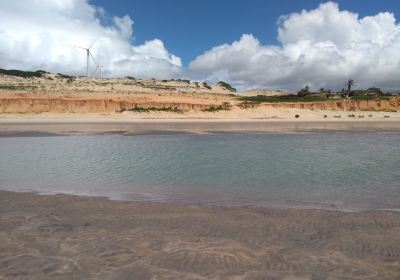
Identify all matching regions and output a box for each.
[0,133,400,209]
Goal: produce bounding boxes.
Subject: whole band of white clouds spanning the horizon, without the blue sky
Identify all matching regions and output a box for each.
[0,0,400,90]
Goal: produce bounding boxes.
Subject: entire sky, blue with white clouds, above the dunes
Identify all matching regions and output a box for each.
[0,0,400,91]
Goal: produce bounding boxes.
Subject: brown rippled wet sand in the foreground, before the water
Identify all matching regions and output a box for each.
[0,192,400,280]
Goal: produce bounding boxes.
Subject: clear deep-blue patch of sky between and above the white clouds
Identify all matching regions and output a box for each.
[91,0,400,65]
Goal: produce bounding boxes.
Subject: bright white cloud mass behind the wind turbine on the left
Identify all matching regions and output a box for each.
[0,0,182,78]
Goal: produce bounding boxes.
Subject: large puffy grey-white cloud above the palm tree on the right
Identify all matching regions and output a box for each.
[189,2,400,90]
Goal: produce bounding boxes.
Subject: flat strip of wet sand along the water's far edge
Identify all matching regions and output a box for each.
[0,118,400,136]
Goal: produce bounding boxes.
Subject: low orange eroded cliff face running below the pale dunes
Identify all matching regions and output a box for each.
[0,94,400,114]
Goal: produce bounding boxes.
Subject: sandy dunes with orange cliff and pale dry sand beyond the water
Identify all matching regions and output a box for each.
[0,72,400,119]
